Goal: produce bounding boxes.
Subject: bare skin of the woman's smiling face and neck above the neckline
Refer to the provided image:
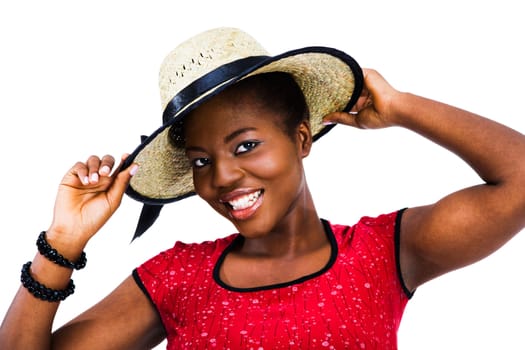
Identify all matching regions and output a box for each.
[185,87,330,287]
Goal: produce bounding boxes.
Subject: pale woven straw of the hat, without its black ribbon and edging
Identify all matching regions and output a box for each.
[130,28,355,202]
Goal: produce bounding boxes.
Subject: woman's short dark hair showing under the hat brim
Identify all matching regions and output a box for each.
[169,72,310,148]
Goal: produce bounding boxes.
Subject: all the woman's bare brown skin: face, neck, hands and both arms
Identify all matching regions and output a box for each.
[0,70,525,349]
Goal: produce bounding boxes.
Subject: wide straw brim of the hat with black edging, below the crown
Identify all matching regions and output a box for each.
[122,47,363,205]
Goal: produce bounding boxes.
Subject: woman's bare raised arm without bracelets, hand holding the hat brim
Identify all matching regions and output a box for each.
[325,70,525,290]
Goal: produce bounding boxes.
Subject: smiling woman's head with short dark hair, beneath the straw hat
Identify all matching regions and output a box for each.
[184,73,313,235]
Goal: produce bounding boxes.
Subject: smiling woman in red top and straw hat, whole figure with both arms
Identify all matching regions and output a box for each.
[0,29,525,349]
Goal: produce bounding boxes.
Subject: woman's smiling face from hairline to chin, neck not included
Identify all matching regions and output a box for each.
[184,89,311,237]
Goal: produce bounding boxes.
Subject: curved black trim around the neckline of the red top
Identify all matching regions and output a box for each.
[213,219,339,292]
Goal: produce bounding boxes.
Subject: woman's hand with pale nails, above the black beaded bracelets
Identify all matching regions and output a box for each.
[46,155,137,257]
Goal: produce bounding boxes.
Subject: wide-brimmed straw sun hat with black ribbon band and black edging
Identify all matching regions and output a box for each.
[123,28,363,237]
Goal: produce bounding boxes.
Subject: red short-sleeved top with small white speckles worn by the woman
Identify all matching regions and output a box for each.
[133,211,411,349]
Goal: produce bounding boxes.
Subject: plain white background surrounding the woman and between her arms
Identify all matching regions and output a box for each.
[0,0,525,349]
